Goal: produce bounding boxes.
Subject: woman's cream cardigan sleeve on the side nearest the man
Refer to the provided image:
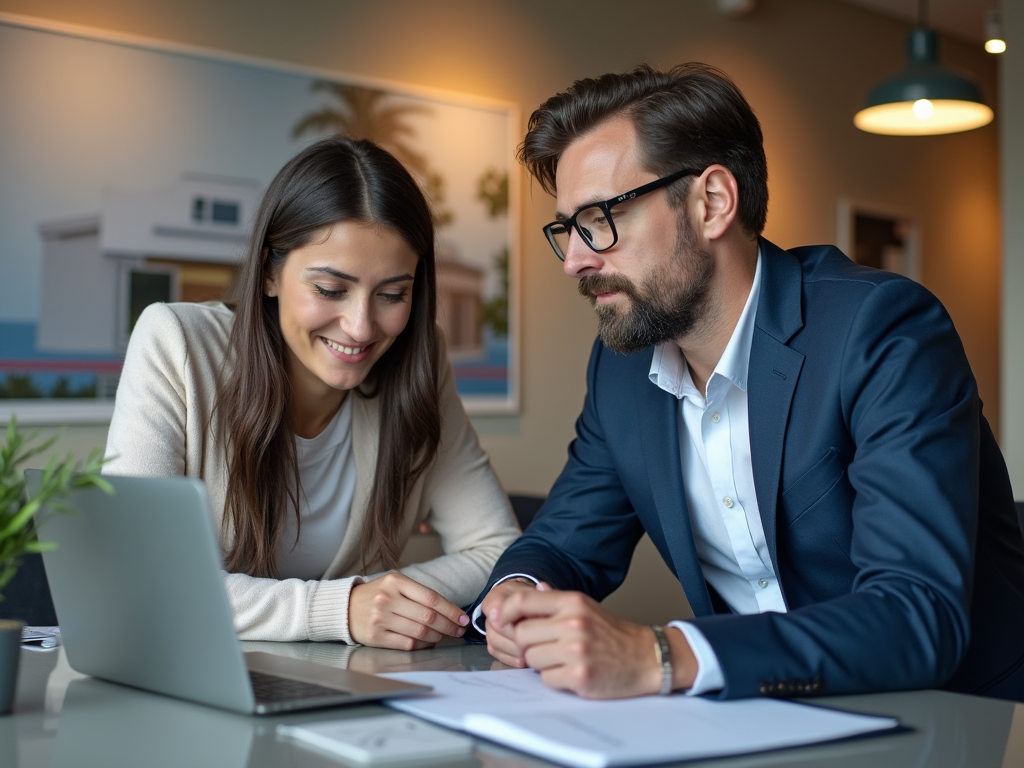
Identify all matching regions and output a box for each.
[401,356,519,606]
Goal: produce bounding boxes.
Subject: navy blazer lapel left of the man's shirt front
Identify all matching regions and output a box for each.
[635,370,715,616]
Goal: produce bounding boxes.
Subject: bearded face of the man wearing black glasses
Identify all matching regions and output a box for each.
[556,118,715,353]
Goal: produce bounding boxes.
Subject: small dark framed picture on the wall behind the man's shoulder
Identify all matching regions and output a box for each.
[836,198,921,281]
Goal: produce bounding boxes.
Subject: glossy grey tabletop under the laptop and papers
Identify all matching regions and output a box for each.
[0,643,1024,768]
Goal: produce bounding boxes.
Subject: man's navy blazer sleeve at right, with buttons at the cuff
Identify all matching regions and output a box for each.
[693,281,980,698]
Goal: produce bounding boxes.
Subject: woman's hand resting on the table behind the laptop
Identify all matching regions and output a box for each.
[348,573,469,650]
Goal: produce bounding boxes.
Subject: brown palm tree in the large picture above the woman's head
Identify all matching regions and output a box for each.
[292,80,454,226]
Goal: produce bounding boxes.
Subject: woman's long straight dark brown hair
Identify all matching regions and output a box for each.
[217,137,440,578]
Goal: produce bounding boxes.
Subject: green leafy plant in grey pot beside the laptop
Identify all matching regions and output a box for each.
[0,416,113,715]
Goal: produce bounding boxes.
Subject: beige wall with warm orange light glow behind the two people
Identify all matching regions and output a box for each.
[0,0,999,493]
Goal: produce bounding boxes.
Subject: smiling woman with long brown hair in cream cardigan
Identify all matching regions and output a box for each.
[105,138,518,650]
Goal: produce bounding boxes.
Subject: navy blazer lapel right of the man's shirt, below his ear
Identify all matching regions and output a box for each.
[746,240,804,583]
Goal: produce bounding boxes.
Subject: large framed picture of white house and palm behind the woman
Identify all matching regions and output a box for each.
[0,13,519,423]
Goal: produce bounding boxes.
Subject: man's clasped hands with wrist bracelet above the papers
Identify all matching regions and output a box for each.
[482,580,697,698]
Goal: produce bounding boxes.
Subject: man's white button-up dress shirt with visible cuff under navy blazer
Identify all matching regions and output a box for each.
[649,254,785,694]
